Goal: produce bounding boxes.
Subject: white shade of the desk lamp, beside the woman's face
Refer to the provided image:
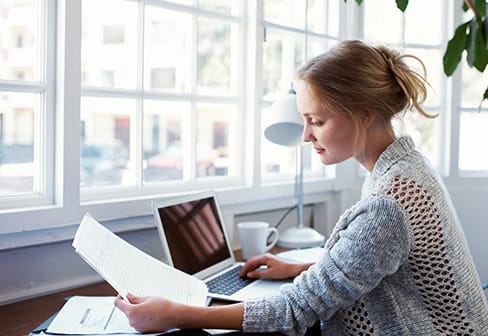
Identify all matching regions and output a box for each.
[264,93,303,147]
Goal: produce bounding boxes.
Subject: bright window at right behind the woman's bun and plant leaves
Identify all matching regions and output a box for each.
[363,0,488,176]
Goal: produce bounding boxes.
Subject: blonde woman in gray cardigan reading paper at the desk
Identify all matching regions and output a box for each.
[115,41,488,335]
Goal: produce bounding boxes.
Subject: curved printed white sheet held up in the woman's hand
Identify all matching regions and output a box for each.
[73,213,208,306]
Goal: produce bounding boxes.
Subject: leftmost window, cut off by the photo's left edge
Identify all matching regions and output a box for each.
[0,0,54,208]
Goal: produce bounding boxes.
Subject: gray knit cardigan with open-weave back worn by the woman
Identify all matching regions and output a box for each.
[242,136,488,336]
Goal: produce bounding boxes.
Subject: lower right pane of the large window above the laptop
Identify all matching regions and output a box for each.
[196,104,236,177]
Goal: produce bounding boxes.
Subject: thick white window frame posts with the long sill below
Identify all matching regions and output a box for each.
[0,0,349,242]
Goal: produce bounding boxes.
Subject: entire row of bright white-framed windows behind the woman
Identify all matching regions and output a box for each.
[8,0,488,233]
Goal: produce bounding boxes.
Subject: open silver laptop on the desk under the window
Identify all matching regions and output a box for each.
[152,191,292,301]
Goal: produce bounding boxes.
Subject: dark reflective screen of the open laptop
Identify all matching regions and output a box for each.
[157,196,231,274]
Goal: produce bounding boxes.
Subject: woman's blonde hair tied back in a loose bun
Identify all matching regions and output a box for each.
[297,40,436,145]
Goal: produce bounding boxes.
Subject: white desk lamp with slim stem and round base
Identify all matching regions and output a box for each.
[264,89,324,248]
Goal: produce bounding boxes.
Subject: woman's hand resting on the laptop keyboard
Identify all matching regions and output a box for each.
[240,253,312,280]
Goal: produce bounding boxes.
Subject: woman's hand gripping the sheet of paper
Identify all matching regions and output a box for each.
[114,294,180,333]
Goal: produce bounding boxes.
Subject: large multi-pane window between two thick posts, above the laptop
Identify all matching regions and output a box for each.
[80,0,244,199]
